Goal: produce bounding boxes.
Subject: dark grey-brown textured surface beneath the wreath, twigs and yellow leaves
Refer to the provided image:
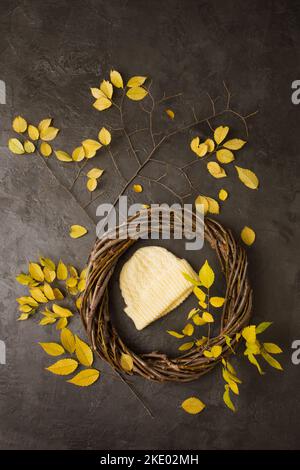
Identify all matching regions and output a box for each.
[0,0,300,449]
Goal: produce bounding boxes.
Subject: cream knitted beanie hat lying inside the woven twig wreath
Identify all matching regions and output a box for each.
[120,246,198,330]
